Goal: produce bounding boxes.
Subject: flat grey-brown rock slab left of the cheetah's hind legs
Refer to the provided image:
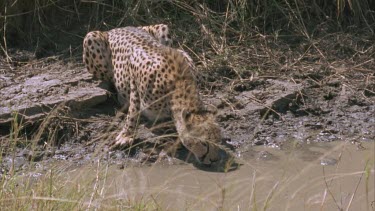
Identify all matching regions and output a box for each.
[0,64,108,125]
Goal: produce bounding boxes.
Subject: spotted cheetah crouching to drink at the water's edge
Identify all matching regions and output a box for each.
[83,26,225,165]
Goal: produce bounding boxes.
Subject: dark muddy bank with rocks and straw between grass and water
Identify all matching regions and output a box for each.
[0,46,375,175]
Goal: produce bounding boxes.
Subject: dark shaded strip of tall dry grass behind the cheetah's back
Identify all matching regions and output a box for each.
[0,0,375,61]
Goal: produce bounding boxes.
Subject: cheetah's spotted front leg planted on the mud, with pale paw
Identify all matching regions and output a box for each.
[113,80,140,147]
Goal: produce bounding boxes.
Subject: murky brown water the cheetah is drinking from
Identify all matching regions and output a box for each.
[50,142,375,210]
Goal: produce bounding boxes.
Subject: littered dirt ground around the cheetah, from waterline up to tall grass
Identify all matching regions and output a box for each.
[0,28,375,173]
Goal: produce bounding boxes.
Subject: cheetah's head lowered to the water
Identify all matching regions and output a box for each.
[178,110,226,165]
